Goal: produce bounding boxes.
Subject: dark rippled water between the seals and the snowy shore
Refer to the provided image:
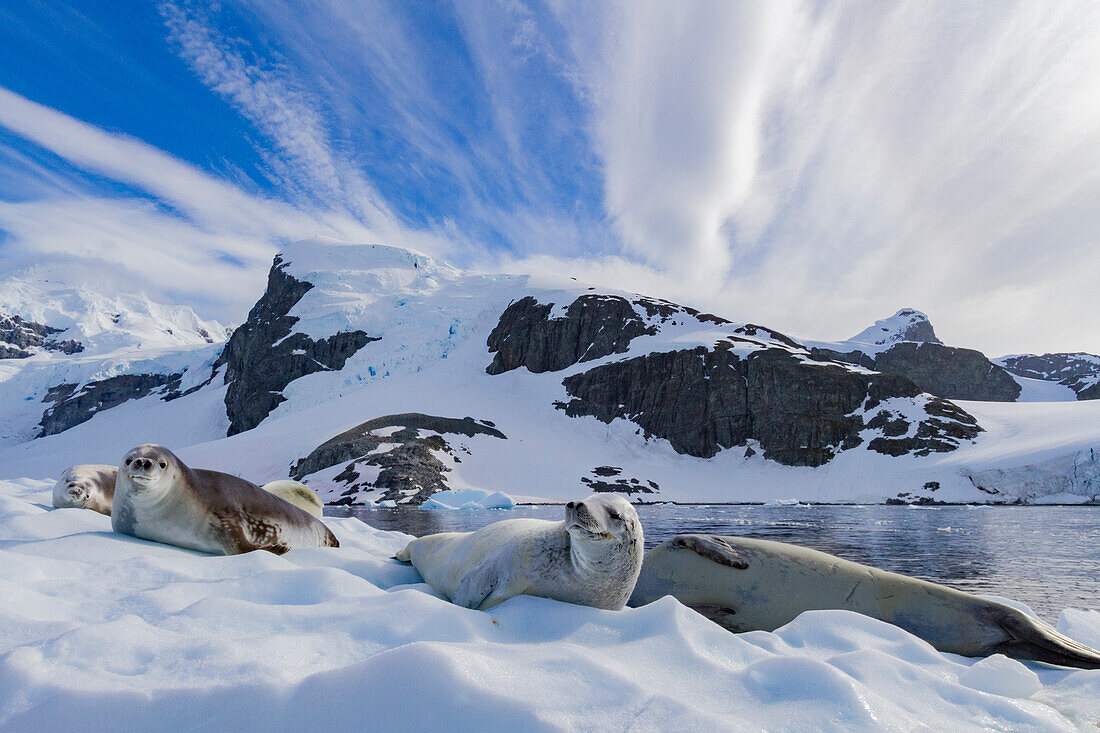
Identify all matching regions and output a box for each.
[326,505,1100,622]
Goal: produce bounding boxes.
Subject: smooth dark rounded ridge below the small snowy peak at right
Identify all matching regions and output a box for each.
[812,341,1020,402]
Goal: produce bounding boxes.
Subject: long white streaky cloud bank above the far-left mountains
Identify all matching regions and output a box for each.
[0,88,448,322]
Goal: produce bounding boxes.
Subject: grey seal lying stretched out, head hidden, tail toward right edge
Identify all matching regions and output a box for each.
[630,535,1100,669]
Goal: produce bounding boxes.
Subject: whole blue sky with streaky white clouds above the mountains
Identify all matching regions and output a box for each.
[0,0,1100,353]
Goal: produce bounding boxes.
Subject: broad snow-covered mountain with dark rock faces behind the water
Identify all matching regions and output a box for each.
[0,240,1100,503]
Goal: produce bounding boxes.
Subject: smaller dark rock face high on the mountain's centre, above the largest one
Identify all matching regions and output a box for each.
[485,295,657,374]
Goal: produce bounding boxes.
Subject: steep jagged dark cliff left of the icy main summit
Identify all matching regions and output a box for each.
[213,256,378,435]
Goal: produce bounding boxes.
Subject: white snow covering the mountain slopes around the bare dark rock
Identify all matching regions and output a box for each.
[0,240,1100,502]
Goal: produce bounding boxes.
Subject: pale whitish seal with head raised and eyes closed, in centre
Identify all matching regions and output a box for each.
[396,494,644,610]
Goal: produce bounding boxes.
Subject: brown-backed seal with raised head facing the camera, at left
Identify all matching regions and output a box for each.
[111,445,340,555]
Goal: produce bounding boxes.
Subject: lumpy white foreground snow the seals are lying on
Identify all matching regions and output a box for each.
[0,481,1100,733]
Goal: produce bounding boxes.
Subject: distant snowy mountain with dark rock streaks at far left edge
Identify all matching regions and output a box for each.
[0,271,229,446]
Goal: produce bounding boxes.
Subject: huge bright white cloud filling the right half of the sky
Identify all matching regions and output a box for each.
[560,1,1100,352]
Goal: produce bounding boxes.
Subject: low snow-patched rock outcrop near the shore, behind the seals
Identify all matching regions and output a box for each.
[290,413,505,504]
